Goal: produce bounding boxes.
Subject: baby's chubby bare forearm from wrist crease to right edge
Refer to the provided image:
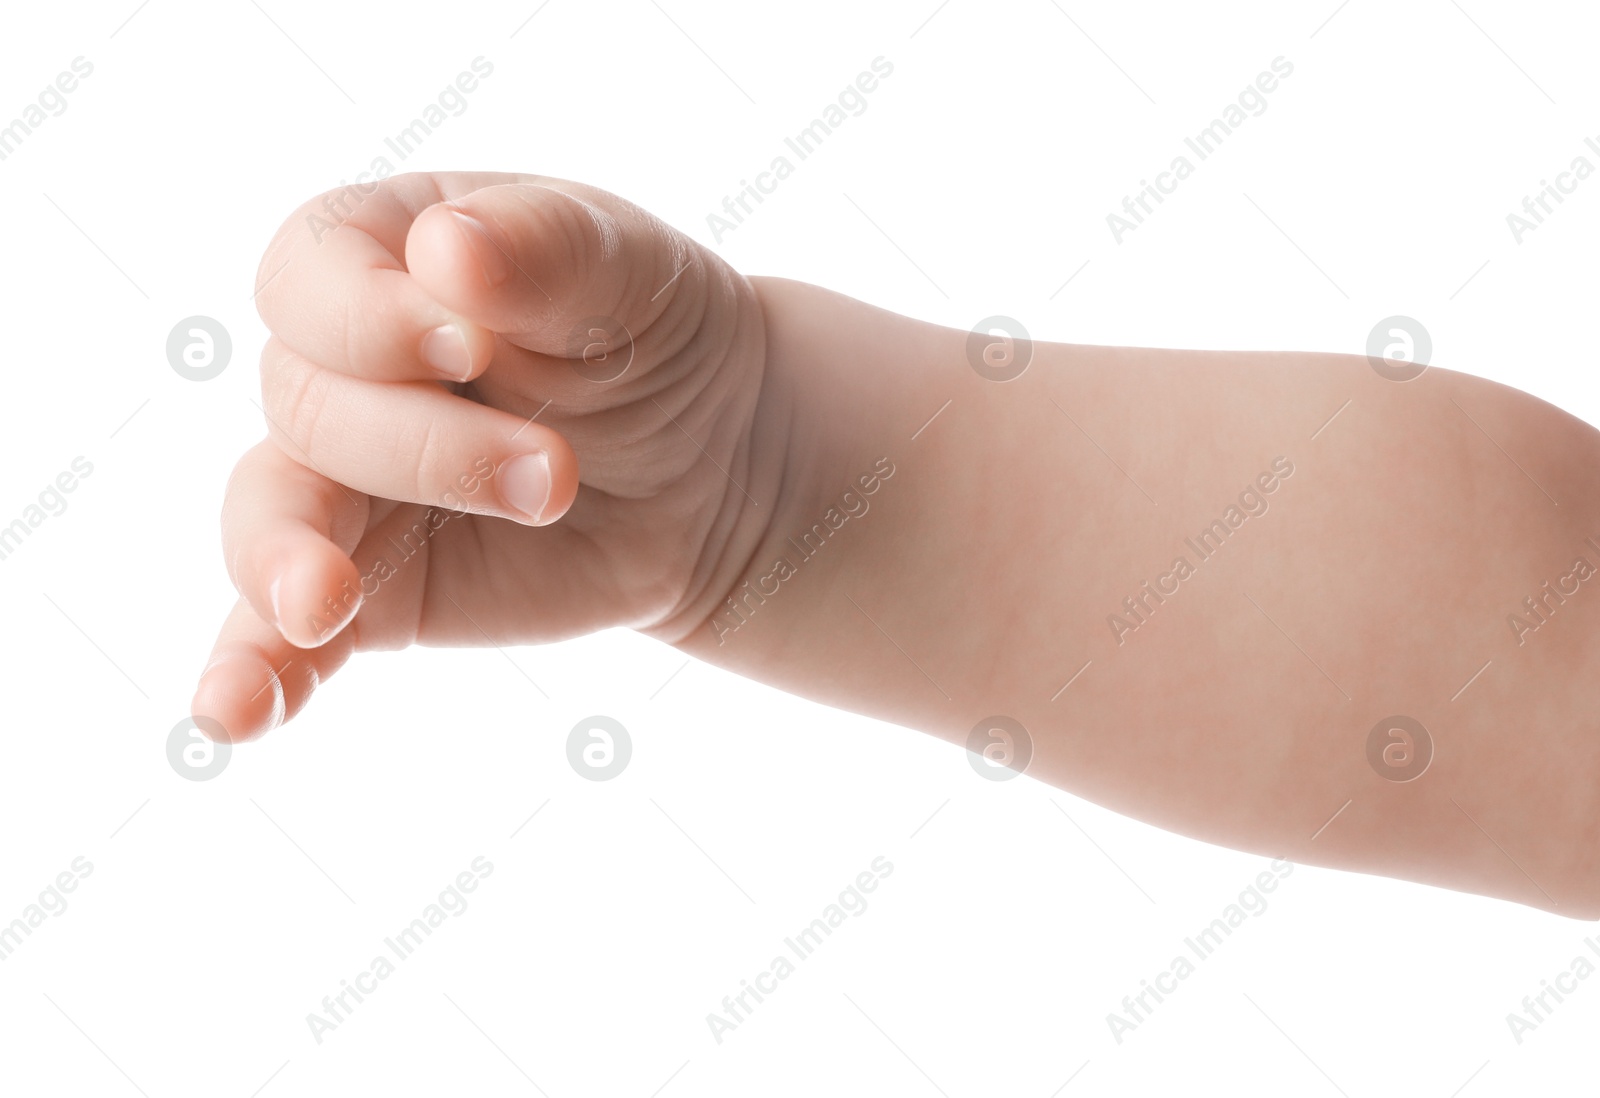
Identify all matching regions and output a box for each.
[683,280,1600,914]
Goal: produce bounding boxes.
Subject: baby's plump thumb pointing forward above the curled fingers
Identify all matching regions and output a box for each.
[405,179,694,359]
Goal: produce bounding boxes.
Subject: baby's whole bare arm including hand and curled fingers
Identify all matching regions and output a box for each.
[192,173,1600,919]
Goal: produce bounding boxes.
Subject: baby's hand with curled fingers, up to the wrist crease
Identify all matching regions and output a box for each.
[192,173,782,739]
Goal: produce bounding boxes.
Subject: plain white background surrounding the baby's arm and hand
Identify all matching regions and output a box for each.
[0,0,1600,1098]
